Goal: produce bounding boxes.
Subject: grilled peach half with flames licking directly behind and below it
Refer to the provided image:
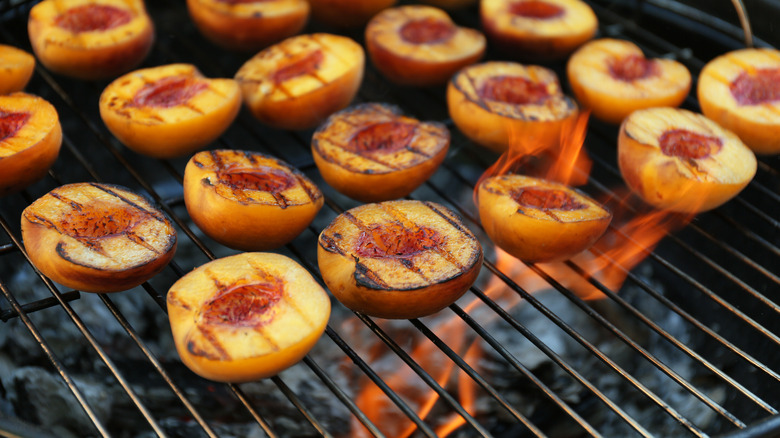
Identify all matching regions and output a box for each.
[478,174,612,262]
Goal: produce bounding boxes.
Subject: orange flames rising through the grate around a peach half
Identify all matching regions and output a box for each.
[353,108,693,437]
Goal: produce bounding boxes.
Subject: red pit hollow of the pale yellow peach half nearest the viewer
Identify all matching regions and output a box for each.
[201,280,284,327]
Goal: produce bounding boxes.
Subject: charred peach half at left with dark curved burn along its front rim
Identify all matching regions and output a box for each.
[22,183,176,292]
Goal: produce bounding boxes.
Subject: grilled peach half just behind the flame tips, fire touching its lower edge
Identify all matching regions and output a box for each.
[447,61,578,152]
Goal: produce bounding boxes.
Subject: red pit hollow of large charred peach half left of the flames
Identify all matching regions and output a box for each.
[356,223,444,258]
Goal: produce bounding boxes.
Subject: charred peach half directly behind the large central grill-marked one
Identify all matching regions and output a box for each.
[312,103,450,202]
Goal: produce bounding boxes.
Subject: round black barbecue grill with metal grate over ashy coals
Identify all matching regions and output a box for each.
[0,0,780,437]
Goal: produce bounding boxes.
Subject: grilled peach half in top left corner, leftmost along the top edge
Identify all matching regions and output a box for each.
[27,0,154,79]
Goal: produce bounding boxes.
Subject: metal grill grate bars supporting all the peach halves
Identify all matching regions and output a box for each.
[0,0,780,437]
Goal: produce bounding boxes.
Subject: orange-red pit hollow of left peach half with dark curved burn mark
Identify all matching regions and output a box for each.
[60,200,143,239]
